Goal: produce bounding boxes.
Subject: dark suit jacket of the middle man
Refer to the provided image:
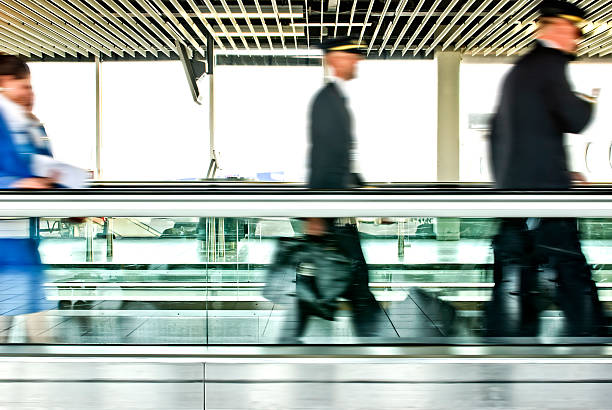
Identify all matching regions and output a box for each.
[308,82,359,189]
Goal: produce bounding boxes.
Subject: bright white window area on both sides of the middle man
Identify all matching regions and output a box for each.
[215,61,436,181]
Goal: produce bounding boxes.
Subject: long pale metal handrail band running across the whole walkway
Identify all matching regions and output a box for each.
[0,188,612,218]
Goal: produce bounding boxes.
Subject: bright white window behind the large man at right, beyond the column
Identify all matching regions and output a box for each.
[460,62,612,182]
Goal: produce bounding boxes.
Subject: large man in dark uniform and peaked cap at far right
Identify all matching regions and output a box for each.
[487,0,603,336]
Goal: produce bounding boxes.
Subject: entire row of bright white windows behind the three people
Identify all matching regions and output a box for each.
[31,57,612,182]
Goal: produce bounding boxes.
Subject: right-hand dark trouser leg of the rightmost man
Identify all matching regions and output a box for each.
[535,218,605,336]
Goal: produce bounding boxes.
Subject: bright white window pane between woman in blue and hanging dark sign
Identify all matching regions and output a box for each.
[102,61,209,180]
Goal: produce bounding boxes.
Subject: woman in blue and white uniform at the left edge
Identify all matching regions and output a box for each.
[0,55,57,342]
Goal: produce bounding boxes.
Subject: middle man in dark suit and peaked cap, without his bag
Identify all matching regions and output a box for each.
[284,37,382,337]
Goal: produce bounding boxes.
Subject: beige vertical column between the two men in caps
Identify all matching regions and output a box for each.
[435,52,461,240]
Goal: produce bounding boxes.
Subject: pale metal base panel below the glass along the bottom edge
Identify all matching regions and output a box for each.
[0,356,612,410]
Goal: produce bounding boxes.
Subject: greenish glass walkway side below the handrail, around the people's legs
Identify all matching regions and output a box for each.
[0,217,612,344]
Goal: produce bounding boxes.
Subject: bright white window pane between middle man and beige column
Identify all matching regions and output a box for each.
[347,60,437,182]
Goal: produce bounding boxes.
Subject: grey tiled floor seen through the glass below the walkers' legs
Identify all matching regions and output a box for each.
[0,295,596,344]
